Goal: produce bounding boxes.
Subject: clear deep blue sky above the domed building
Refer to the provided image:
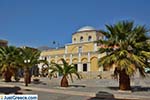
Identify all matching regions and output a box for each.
[0,0,150,47]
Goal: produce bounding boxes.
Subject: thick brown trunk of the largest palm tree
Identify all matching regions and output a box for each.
[119,70,131,90]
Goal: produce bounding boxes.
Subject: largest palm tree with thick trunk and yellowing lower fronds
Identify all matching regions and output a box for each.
[97,21,150,90]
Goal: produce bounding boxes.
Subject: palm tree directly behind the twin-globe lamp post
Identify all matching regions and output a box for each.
[17,47,40,86]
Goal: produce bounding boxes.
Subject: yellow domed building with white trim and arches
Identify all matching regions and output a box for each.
[40,26,107,79]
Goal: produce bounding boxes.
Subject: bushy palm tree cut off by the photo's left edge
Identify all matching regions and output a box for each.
[0,46,18,82]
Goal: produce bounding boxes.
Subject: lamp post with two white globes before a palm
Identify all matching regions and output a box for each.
[24,59,30,86]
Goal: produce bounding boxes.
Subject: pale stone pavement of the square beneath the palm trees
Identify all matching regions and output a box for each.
[0,78,150,100]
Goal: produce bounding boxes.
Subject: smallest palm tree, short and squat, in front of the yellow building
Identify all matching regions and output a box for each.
[50,59,80,87]
